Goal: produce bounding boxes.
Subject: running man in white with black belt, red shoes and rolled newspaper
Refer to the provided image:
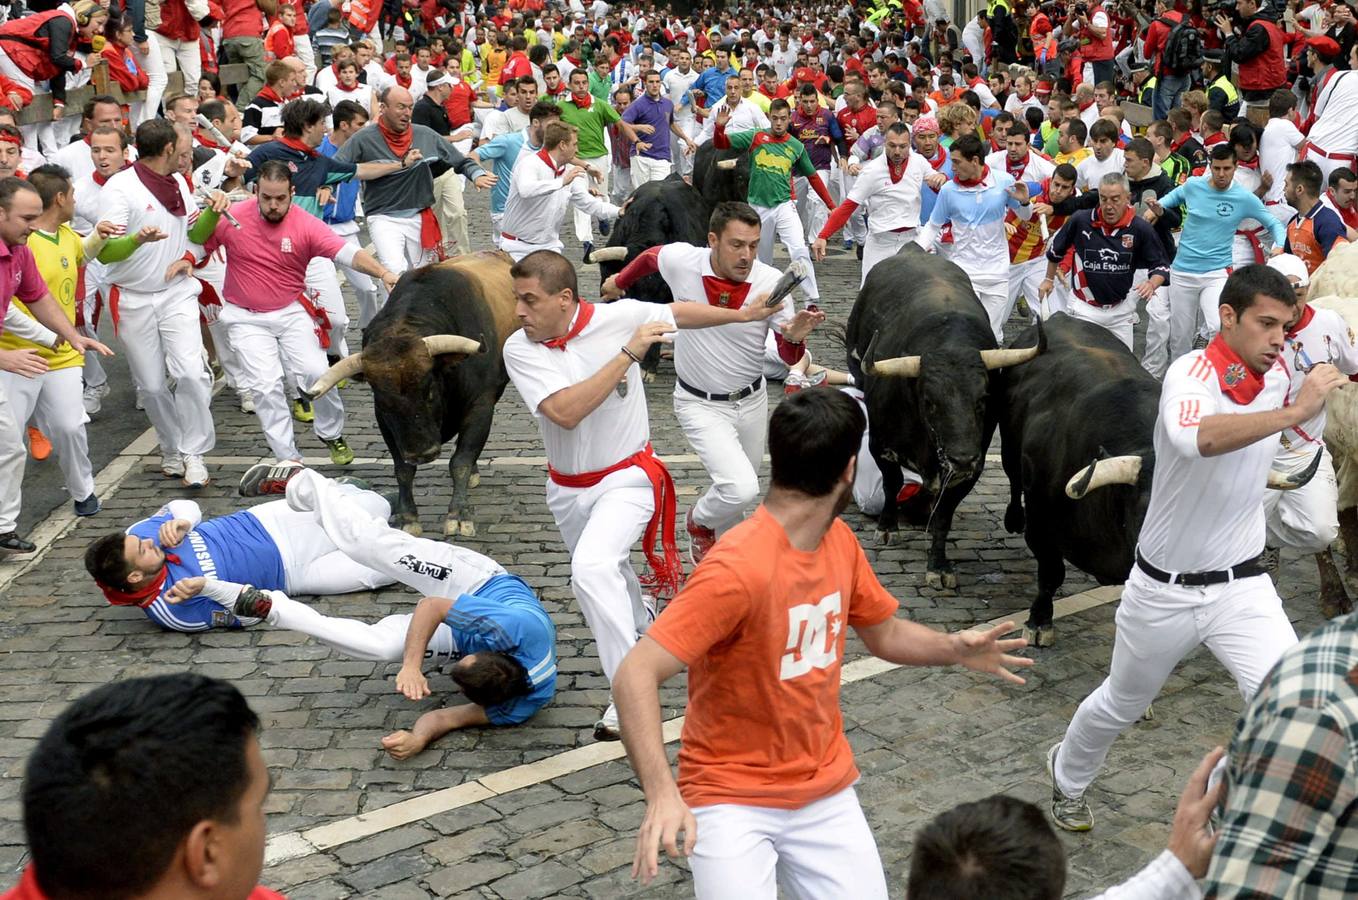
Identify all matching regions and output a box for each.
[600,202,826,565]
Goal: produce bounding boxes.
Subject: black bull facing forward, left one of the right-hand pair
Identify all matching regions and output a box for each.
[846,244,1042,588]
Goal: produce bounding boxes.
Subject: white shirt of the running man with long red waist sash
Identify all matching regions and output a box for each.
[504,300,675,475]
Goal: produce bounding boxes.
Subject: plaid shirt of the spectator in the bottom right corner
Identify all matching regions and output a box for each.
[1203,615,1358,900]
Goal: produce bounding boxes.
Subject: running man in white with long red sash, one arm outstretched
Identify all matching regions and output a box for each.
[504,250,778,740]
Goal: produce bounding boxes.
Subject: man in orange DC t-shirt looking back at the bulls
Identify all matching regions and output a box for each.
[612,390,1032,900]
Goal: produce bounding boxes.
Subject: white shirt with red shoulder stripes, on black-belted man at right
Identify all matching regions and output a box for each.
[1138,344,1289,571]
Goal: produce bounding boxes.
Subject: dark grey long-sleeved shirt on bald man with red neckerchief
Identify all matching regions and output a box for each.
[334,122,486,216]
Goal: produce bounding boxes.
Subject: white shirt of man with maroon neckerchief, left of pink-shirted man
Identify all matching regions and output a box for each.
[99,166,198,293]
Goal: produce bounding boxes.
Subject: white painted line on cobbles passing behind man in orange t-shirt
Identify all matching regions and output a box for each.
[263,585,1122,866]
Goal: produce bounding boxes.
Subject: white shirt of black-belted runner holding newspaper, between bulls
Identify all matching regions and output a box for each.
[657,243,796,396]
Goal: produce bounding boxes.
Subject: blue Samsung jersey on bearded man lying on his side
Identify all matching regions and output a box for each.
[128,501,288,631]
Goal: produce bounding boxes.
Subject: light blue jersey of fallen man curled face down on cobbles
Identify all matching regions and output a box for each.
[444,574,557,725]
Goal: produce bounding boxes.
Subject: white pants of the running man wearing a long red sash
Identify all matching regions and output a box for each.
[547,466,655,681]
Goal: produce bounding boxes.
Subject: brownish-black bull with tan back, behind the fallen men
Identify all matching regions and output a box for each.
[308,252,519,538]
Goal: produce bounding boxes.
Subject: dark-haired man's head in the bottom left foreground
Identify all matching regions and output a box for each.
[4,672,284,900]
